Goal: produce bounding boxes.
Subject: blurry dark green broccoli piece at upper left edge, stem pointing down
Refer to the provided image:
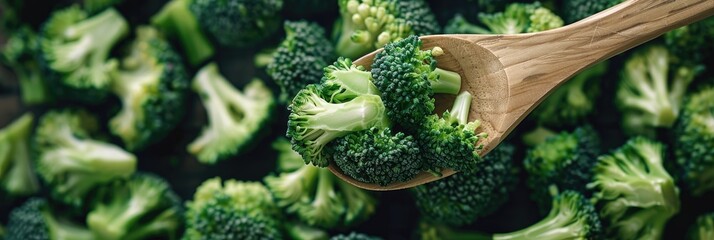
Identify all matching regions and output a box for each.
[0,26,53,105]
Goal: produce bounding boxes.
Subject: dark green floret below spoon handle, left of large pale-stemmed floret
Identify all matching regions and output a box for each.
[523,126,600,212]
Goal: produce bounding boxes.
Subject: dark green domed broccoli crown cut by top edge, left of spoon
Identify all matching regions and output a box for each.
[189,0,283,47]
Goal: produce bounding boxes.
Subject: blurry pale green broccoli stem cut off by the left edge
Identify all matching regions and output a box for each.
[0,113,40,197]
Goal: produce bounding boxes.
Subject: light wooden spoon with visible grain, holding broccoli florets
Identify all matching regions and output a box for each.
[329,0,714,191]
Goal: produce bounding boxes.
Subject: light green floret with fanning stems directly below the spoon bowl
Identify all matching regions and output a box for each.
[265,137,376,229]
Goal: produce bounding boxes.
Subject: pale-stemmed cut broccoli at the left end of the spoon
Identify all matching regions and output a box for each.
[286,58,389,167]
